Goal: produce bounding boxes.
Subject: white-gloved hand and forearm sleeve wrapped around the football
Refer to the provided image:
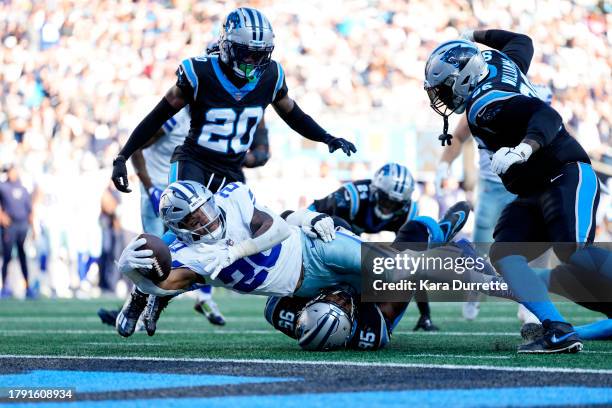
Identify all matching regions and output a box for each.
[117,238,179,296]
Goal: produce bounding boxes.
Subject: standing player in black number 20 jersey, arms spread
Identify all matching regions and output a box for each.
[112,7,356,335]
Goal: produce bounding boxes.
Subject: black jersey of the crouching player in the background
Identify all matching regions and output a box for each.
[310,180,418,234]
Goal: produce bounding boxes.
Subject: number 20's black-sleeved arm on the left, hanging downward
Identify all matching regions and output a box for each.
[111,85,187,193]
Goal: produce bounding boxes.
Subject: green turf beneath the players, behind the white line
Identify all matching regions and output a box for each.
[0,292,612,369]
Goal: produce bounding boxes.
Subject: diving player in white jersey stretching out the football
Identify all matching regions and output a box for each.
[119,181,510,346]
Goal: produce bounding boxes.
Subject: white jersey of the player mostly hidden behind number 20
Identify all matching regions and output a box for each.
[142,106,191,190]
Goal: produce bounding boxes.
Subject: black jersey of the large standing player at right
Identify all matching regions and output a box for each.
[466,49,590,195]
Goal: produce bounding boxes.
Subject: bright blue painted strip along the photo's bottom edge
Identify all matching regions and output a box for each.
[0,386,612,408]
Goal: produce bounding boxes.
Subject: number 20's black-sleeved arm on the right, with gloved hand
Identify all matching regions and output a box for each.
[272,95,357,156]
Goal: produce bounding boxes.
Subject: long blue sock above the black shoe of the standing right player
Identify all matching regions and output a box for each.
[496,255,565,322]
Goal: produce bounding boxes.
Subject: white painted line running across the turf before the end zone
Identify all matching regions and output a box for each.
[0,354,612,374]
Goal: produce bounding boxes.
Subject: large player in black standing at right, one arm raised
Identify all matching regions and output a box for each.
[425,30,599,353]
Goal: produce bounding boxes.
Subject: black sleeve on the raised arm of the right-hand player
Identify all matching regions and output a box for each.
[474,30,533,74]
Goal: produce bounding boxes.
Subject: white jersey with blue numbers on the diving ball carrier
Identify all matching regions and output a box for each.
[170,183,302,296]
